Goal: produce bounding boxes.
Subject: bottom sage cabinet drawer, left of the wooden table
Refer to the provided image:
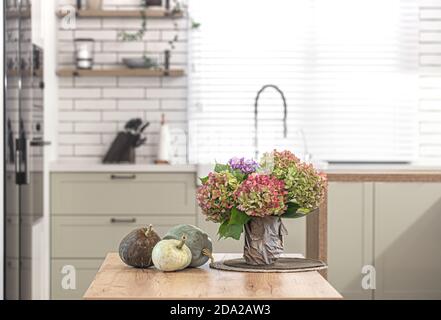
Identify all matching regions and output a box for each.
[51,259,103,300]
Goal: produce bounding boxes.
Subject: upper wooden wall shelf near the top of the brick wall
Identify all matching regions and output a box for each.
[57,9,183,18]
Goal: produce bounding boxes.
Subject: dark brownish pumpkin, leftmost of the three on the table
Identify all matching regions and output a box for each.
[119,225,161,268]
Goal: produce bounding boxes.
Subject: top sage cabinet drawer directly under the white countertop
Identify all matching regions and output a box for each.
[51,173,196,215]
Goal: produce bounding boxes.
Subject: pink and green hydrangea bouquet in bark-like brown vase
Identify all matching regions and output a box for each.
[197,150,327,265]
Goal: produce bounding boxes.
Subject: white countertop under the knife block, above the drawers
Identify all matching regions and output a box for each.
[50,161,197,173]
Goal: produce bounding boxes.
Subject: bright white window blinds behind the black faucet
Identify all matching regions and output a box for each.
[189,0,418,163]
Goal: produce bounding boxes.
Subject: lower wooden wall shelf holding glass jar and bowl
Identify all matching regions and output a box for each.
[57,68,185,77]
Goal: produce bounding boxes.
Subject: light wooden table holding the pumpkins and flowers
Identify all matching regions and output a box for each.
[84,253,342,300]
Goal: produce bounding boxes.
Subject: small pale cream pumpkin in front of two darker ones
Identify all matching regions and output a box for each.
[152,235,192,271]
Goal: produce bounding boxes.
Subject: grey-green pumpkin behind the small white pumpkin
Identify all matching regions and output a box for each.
[164,224,213,268]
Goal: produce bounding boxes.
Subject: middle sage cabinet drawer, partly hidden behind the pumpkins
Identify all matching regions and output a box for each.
[51,215,196,258]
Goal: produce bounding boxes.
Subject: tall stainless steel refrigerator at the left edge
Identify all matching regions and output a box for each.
[3,0,45,299]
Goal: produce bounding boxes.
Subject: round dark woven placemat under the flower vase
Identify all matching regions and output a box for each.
[210,258,328,272]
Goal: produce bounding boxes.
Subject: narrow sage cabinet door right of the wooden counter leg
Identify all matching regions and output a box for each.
[328,182,374,299]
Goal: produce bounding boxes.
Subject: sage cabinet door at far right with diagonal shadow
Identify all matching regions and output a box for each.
[375,182,441,299]
